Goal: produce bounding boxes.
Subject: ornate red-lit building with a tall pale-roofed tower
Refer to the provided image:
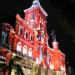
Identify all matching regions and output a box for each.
[0,0,66,75]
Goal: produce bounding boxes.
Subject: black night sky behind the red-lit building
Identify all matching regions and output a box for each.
[0,0,75,68]
